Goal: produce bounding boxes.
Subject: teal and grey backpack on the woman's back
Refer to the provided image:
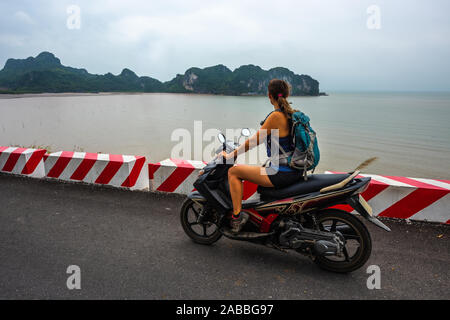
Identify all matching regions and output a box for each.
[288,111,320,180]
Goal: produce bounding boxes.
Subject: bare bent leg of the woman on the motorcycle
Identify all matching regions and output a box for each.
[228,165,273,215]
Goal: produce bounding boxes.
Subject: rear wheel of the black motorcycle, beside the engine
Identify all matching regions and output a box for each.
[314,209,372,273]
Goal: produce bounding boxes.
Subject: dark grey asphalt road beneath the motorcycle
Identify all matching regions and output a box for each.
[0,174,450,299]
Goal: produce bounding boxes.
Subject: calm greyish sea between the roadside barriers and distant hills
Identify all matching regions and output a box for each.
[0,93,450,179]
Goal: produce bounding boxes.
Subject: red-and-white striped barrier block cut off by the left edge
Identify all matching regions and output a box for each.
[0,147,46,178]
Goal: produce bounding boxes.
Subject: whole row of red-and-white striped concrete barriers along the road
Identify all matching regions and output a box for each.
[0,147,450,224]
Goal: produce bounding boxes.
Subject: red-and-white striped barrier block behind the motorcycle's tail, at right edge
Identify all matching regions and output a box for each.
[326,171,450,224]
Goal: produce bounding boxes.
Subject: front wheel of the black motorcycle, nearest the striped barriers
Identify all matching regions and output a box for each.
[180,198,222,245]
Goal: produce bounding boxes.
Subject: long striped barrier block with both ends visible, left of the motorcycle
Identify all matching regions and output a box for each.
[44,151,149,190]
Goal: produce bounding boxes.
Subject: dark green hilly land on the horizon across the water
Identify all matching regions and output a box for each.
[0,52,319,96]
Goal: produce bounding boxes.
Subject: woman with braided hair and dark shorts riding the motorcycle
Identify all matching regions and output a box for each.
[222,79,302,233]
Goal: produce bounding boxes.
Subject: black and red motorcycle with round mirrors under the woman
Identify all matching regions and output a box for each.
[180,129,391,273]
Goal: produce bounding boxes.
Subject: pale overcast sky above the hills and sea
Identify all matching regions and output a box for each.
[0,0,450,91]
